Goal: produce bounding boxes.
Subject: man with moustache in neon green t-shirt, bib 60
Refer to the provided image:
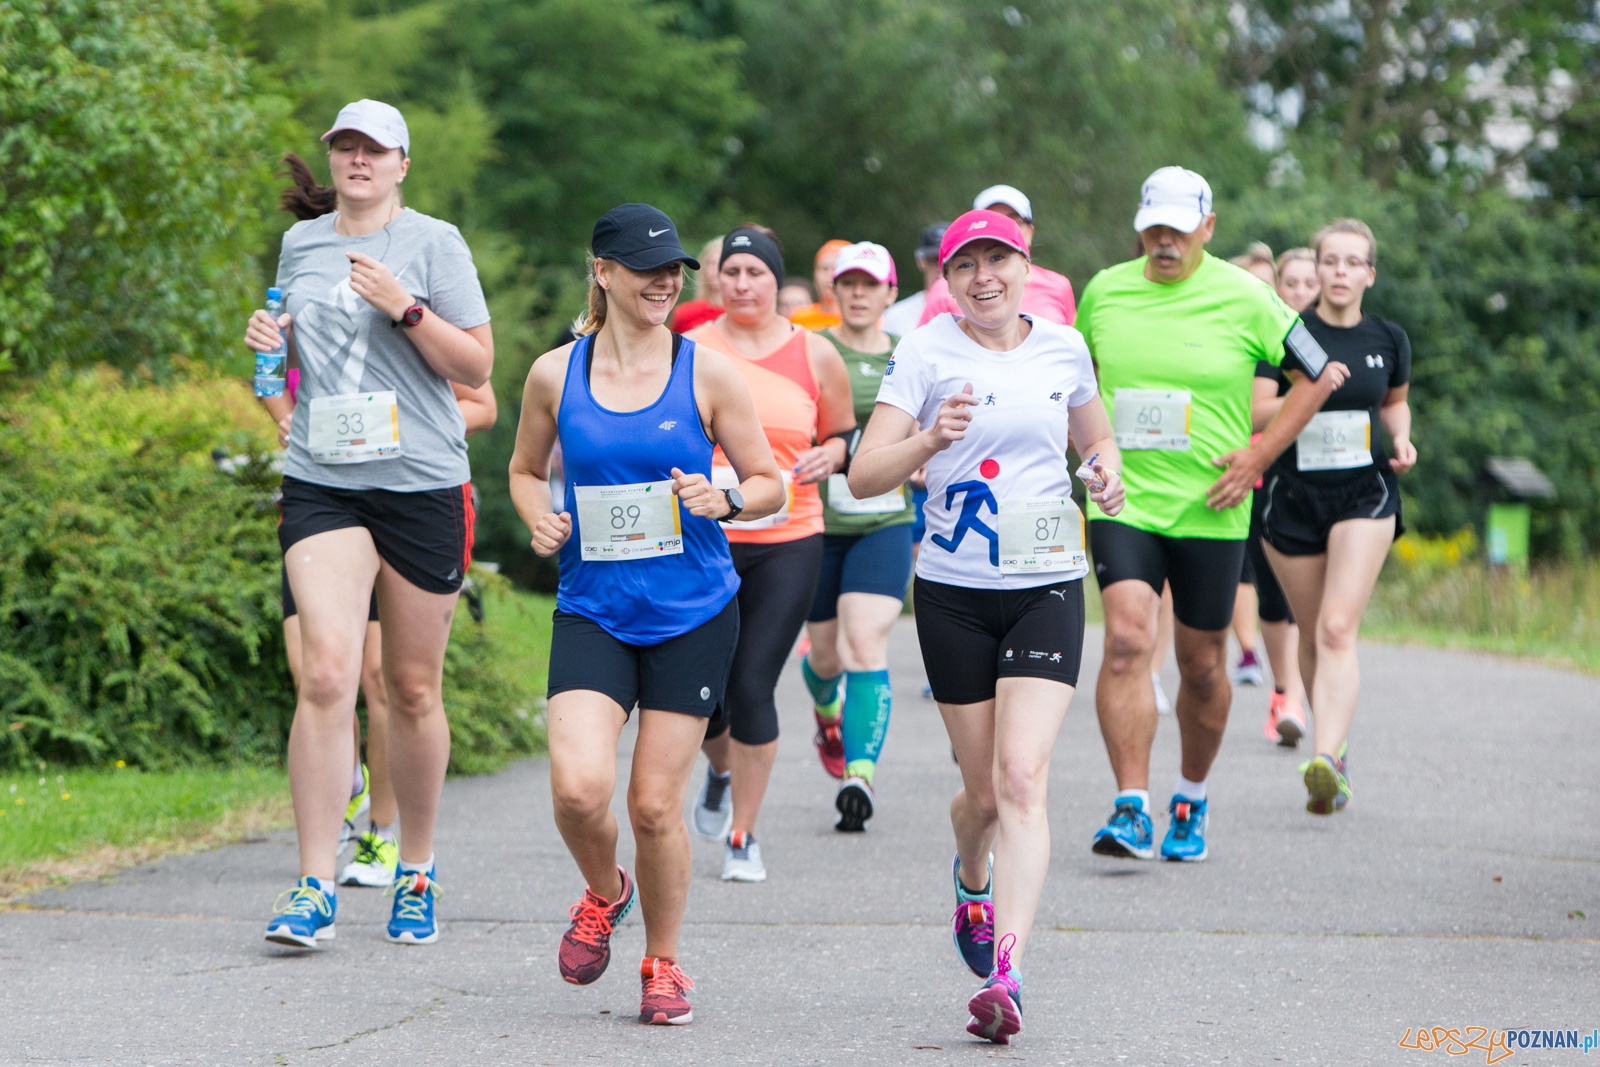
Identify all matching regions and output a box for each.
[1075,166,1347,862]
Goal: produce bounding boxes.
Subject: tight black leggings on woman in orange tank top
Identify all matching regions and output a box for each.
[706,534,822,745]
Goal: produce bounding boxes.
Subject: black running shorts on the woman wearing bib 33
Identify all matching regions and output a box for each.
[278,477,474,593]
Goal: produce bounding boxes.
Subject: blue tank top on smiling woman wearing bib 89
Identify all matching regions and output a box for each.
[555,334,739,645]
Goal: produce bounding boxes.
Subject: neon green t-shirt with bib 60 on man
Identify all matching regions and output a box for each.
[1077,254,1298,541]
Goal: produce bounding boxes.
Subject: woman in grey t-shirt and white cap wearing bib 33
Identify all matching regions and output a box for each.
[245,101,494,947]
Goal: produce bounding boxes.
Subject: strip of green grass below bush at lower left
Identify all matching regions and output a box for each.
[0,765,290,896]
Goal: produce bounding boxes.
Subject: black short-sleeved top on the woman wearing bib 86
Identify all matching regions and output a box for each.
[1256,304,1411,485]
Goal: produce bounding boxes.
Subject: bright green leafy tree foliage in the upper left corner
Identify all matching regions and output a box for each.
[0,0,293,373]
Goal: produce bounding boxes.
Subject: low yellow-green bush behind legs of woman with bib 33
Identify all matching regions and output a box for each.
[0,370,542,774]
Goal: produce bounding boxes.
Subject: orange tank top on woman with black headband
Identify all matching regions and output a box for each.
[686,322,822,544]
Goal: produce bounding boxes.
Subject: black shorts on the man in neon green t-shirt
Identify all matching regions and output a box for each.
[1090,518,1245,630]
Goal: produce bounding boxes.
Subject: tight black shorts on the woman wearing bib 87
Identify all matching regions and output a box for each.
[912,577,1083,704]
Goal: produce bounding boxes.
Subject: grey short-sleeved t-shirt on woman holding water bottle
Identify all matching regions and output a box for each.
[278,208,490,493]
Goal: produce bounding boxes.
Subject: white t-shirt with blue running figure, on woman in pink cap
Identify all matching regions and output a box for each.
[878,314,1098,589]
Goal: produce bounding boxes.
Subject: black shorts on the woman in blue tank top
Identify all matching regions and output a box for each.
[549,601,739,718]
